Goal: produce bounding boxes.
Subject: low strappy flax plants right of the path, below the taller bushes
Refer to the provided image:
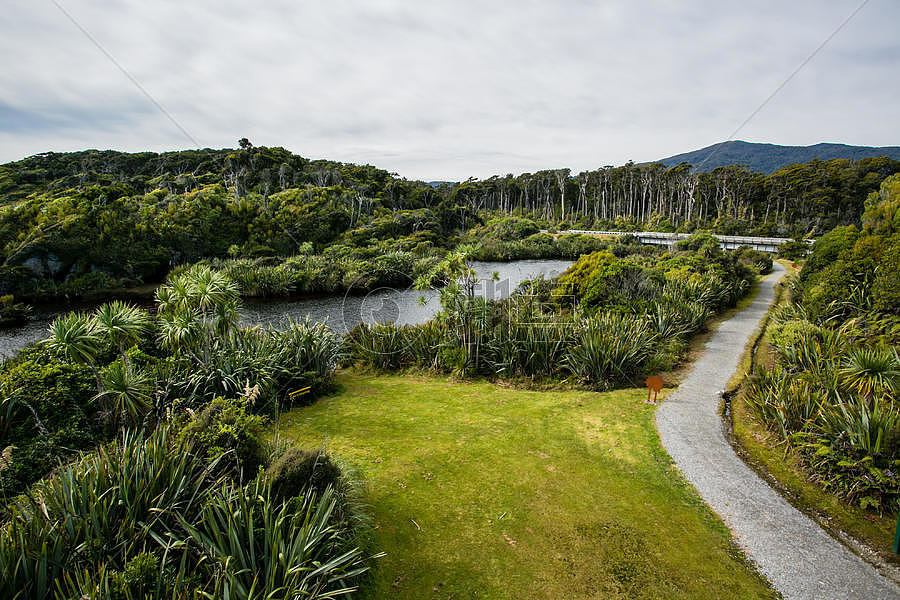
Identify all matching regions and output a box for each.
[743,308,900,512]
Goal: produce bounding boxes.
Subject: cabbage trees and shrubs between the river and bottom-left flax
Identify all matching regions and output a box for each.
[0,266,342,495]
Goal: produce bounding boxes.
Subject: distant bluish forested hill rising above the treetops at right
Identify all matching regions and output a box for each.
[656,140,900,173]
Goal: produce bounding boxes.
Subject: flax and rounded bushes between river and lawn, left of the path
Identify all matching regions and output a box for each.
[346,246,755,388]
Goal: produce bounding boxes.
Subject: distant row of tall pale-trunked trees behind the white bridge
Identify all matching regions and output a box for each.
[451,157,900,235]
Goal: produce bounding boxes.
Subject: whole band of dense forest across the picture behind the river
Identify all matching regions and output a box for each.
[0,145,900,315]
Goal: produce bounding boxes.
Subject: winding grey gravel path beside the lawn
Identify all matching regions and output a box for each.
[656,263,900,600]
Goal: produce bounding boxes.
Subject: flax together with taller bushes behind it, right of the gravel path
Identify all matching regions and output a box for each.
[744,241,900,514]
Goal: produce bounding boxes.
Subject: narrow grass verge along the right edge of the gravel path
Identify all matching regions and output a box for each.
[724,261,900,582]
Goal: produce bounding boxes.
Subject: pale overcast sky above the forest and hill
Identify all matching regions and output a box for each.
[0,0,900,181]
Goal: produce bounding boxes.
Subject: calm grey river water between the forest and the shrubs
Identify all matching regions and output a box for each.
[0,260,572,357]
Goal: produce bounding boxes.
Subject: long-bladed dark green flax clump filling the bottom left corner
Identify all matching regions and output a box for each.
[0,429,209,600]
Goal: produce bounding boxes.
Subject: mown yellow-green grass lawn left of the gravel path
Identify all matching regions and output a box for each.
[278,371,775,600]
